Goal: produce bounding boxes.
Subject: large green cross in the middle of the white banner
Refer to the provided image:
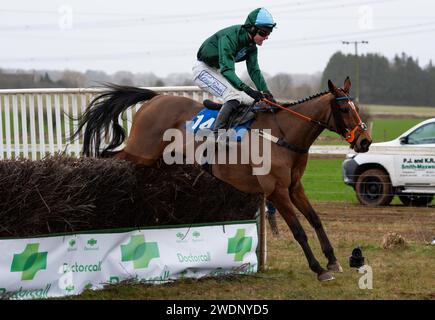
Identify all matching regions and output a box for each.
[121,235,160,269]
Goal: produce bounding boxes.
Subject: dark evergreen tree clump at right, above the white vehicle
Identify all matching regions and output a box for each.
[322,52,435,106]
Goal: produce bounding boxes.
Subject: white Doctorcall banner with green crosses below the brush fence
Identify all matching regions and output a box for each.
[0,221,258,299]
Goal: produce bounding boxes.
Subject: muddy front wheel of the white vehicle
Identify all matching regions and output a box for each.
[355,169,394,206]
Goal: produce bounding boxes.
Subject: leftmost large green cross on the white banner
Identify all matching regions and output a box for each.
[11,243,48,280]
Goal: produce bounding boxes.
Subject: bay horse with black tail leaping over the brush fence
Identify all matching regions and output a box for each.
[75,77,372,281]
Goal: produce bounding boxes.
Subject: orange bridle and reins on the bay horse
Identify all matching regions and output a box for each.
[262,96,367,144]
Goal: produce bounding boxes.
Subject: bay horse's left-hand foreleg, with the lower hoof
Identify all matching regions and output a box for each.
[268,187,334,281]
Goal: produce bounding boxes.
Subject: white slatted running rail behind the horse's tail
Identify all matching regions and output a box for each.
[0,86,209,160]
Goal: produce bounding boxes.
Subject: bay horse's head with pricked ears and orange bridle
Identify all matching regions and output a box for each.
[328,77,372,152]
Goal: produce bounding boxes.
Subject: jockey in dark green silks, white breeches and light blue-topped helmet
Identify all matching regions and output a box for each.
[192,8,276,138]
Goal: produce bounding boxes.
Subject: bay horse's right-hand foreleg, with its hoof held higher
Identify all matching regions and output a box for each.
[289,181,343,272]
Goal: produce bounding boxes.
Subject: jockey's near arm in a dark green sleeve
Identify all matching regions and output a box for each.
[218,36,246,90]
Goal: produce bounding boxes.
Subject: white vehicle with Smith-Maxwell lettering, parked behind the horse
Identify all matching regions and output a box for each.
[342,118,435,206]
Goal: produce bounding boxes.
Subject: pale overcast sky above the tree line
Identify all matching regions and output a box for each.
[0,0,435,76]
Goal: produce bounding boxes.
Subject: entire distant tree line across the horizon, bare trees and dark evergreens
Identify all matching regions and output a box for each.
[0,52,435,106]
